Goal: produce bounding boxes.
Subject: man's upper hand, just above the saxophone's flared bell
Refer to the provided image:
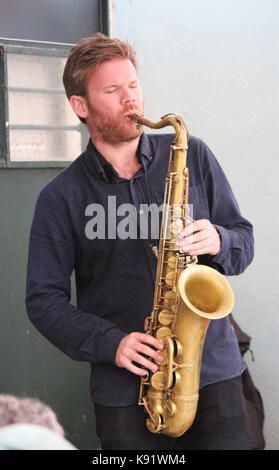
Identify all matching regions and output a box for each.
[178,219,221,256]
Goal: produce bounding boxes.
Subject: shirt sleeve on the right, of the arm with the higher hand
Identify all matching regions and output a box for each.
[199,140,254,276]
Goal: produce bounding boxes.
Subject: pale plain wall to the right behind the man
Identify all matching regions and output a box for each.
[114,0,279,449]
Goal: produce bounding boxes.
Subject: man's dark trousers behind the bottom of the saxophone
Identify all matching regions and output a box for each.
[95,377,251,450]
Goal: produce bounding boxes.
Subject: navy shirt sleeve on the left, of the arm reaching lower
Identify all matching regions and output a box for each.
[26,190,127,364]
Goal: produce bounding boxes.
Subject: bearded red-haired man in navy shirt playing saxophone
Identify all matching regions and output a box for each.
[26,34,253,450]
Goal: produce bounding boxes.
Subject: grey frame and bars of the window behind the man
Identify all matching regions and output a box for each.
[0,38,88,168]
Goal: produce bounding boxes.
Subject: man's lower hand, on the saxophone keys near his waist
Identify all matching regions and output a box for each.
[115,332,164,375]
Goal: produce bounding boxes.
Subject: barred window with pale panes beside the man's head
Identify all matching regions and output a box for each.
[0,39,88,167]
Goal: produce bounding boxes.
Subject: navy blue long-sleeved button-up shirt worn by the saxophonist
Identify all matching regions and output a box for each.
[26,134,253,406]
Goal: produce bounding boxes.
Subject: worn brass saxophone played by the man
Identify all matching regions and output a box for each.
[131,114,234,437]
